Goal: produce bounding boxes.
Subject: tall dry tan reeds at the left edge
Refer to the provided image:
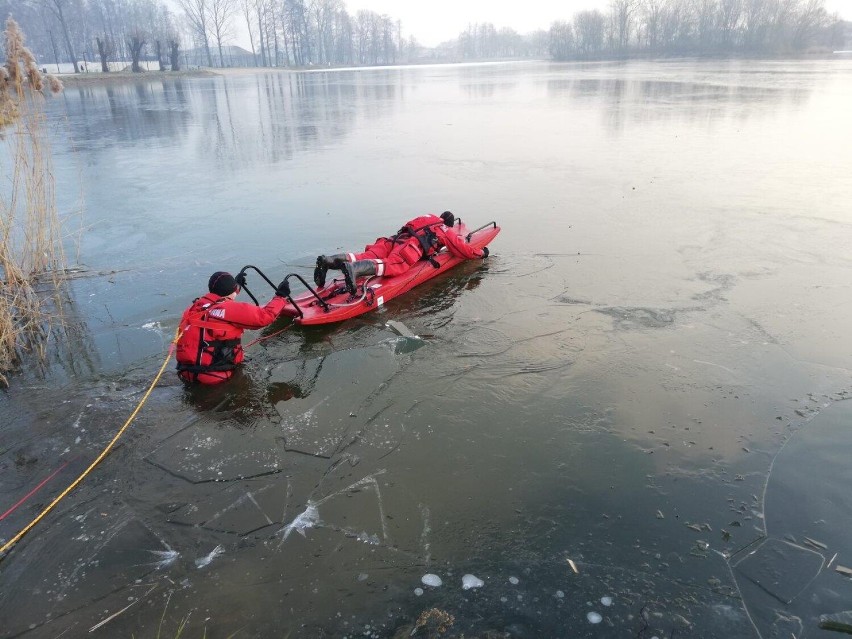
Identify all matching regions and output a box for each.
[0,17,67,385]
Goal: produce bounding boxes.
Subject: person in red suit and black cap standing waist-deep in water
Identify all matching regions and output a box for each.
[175,271,290,384]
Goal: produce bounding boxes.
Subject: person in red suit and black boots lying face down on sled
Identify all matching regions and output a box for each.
[314,211,488,295]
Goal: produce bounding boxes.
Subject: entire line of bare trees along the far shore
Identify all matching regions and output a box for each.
[0,0,844,72]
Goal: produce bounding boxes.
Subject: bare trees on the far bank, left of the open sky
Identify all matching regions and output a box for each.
[0,0,410,73]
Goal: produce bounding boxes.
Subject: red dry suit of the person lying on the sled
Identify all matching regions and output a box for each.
[346,215,483,277]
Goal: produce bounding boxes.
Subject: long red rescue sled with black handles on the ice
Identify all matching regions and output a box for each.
[281,220,500,326]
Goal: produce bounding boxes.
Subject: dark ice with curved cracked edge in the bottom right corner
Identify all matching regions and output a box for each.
[732,400,852,637]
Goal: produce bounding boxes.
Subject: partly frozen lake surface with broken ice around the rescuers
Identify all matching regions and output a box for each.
[0,60,852,639]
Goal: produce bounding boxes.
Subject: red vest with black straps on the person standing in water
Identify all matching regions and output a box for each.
[175,295,243,381]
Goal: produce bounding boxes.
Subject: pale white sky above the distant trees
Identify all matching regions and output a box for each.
[344,0,852,46]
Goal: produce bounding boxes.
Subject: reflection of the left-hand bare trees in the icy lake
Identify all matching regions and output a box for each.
[55,69,403,168]
